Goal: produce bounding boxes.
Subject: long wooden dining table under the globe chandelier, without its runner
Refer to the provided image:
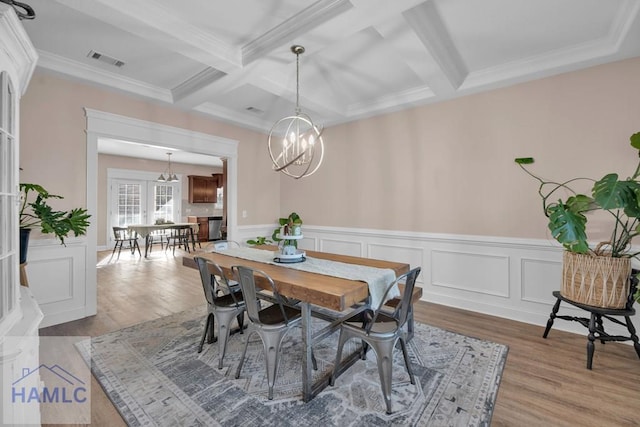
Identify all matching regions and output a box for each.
[191,245,410,402]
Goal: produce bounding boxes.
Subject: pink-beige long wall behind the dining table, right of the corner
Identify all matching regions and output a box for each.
[280,59,640,238]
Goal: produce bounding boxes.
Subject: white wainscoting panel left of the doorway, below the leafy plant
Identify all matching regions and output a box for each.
[26,238,96,328]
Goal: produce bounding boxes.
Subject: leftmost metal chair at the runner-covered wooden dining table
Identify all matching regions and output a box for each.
[194,257,245,369]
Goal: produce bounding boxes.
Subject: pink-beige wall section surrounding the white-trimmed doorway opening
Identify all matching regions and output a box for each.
[20,69,280,241]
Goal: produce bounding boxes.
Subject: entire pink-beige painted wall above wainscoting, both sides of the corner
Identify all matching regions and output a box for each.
[21,55,640,244]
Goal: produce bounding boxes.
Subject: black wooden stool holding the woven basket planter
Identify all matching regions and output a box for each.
[542,270,640,369]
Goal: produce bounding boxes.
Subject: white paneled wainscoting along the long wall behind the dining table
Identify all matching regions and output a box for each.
[235,225,640,345]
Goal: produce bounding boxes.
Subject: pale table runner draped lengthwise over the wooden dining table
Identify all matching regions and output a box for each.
[214,247,400,307]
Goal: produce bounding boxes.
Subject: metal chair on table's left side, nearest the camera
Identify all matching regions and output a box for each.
[231,265,318,400]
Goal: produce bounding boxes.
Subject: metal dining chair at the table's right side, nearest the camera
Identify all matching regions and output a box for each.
[329,267,420,414]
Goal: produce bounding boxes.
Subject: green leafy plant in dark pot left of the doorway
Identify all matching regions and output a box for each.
[20,183,91,264]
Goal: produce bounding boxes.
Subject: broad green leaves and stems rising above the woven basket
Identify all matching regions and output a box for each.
[515,132,640,301]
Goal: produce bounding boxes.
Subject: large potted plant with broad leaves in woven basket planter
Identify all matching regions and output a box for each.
[515,132,640,308]
